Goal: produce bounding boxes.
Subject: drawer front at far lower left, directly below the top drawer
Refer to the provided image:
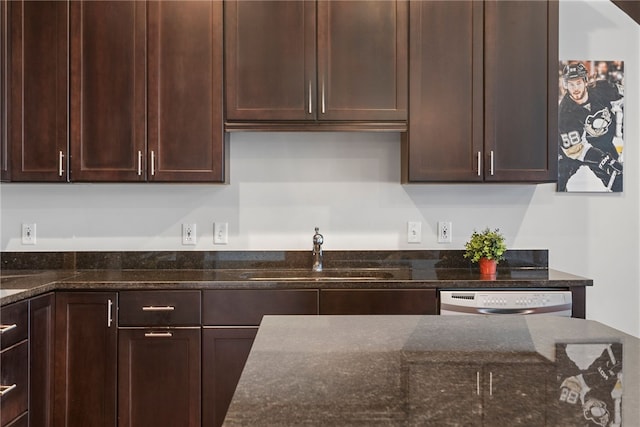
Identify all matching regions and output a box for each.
[0,341,29,426]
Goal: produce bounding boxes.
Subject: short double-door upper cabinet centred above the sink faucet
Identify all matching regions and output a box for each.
[224,0,408,129]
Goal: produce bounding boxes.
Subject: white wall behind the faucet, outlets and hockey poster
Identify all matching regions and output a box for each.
[0,0,640,336]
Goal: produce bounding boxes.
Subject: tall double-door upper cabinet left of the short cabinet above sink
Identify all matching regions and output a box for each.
[71,1,224,182]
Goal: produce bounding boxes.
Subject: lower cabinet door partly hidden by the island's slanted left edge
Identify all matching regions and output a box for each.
[202,328,258,427]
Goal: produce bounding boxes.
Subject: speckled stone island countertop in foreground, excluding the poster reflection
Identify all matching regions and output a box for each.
[224,316,640,427]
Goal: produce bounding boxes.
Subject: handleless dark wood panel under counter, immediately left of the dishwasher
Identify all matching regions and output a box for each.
[320,289,438,314]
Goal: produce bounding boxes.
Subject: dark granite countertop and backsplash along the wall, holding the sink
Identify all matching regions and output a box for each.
[0,250,593,305]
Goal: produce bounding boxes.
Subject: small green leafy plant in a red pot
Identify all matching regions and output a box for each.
[464,227,507,275]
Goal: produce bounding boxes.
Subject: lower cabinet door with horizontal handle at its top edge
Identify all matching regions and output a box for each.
[118,328,201,427]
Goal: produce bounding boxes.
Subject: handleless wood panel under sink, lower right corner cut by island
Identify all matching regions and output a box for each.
[202,289,318,326]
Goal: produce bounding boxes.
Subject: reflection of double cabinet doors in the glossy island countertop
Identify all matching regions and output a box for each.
[406,361,553,427]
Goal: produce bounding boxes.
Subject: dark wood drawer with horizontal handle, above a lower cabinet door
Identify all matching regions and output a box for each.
[118,291,200,326]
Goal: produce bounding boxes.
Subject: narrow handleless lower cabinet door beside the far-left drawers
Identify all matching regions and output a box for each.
[29,294,55,427]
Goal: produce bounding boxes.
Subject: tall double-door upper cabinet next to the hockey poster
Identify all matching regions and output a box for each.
[402,1,558,182]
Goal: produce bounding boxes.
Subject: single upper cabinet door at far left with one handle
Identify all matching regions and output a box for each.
[8,1,69,181]
